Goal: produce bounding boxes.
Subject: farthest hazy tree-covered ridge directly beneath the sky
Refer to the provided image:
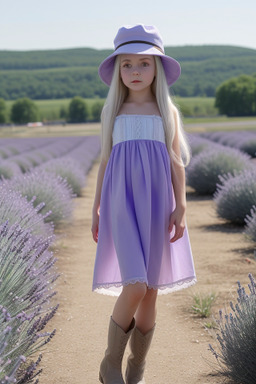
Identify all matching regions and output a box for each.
[0,45,256,70]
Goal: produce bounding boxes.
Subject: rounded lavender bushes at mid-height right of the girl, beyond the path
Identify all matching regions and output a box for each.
[187,131,256,241]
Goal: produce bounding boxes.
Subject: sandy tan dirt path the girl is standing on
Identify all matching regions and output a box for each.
[40,158,256,384]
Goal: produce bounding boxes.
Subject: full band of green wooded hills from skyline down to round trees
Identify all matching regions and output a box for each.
[0,45,256,100]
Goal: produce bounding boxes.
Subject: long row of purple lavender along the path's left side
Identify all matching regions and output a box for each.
[0,136,100,384]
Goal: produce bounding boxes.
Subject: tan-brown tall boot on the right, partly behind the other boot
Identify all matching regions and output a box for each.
[125,326,155,384]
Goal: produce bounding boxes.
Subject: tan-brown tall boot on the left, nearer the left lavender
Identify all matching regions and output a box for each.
[99,317,135,384]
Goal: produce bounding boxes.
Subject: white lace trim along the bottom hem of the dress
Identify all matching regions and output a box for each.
[93,276,197,296]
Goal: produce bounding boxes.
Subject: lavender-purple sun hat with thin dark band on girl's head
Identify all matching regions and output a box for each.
[99,24,181,86]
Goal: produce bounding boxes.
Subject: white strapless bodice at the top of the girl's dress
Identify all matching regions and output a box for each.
[112,115,165,146]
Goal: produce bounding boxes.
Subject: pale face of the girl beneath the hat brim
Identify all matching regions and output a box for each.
[120,54,156,91]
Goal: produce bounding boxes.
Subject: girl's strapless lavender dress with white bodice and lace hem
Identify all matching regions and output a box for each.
[93,115,196,296]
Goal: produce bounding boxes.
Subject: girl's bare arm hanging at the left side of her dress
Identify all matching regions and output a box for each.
[91,160,107,243]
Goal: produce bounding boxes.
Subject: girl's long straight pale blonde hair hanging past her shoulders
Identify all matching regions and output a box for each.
[101,56,190,166]
